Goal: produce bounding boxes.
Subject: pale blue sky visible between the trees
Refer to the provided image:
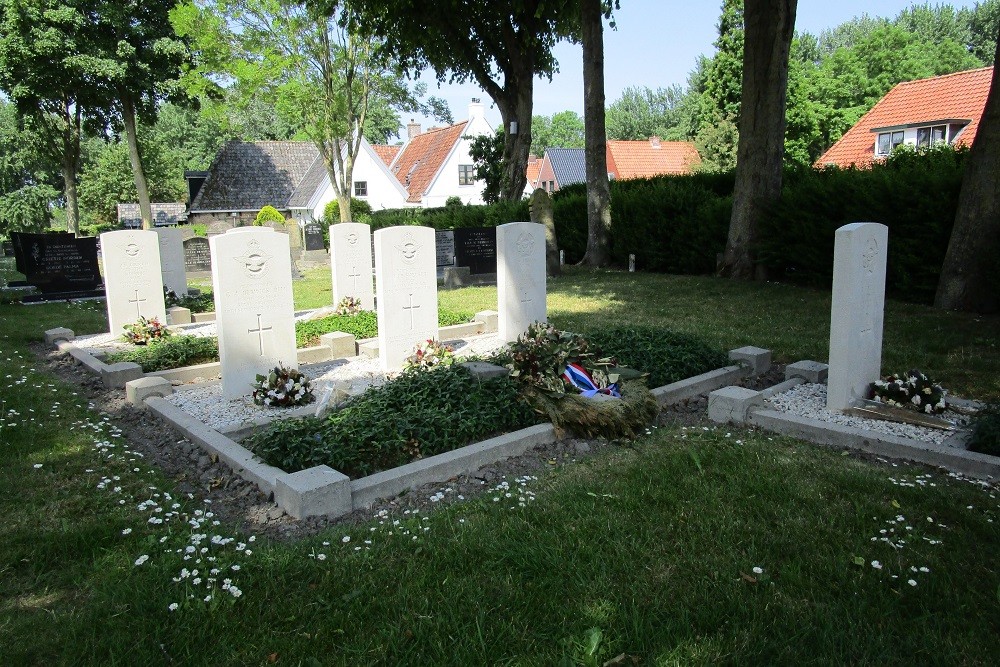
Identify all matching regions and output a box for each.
[403,0,975,134]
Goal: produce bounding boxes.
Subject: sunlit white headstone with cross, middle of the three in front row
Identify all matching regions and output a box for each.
[375,225,438,371]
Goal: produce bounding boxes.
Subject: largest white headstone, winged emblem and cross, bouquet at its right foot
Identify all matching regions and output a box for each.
[208,227,298,398]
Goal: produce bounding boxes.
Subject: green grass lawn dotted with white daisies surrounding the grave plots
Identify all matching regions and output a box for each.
[0,269,1000,665]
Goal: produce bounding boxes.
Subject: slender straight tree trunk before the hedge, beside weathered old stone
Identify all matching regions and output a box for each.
[580,0,611,266]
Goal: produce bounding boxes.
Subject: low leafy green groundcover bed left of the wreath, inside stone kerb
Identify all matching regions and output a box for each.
[247,366,537,479]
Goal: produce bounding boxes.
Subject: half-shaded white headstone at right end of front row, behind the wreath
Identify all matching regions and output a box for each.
[497,222,547,342]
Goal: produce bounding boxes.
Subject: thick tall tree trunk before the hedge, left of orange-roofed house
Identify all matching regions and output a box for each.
[718,0,796,280]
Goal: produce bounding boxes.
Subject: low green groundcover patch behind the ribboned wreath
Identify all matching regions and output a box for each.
[585,325,729,387]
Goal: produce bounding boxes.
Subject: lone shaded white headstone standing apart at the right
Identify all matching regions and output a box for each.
[826,222,889,410]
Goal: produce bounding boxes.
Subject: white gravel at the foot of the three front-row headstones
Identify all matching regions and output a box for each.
[167,334,503,431]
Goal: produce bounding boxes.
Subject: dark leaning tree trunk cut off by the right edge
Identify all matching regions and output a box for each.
[934,35,1000,313]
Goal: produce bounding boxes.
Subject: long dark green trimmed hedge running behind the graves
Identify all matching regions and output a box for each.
[372,146,968,302]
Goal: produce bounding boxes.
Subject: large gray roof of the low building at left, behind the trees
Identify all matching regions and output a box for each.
[191,141,319,213]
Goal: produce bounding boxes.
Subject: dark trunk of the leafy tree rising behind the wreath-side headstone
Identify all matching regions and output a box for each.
[494,69,535,201]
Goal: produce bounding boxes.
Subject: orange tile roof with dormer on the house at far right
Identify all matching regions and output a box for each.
[816,67,993,167]
